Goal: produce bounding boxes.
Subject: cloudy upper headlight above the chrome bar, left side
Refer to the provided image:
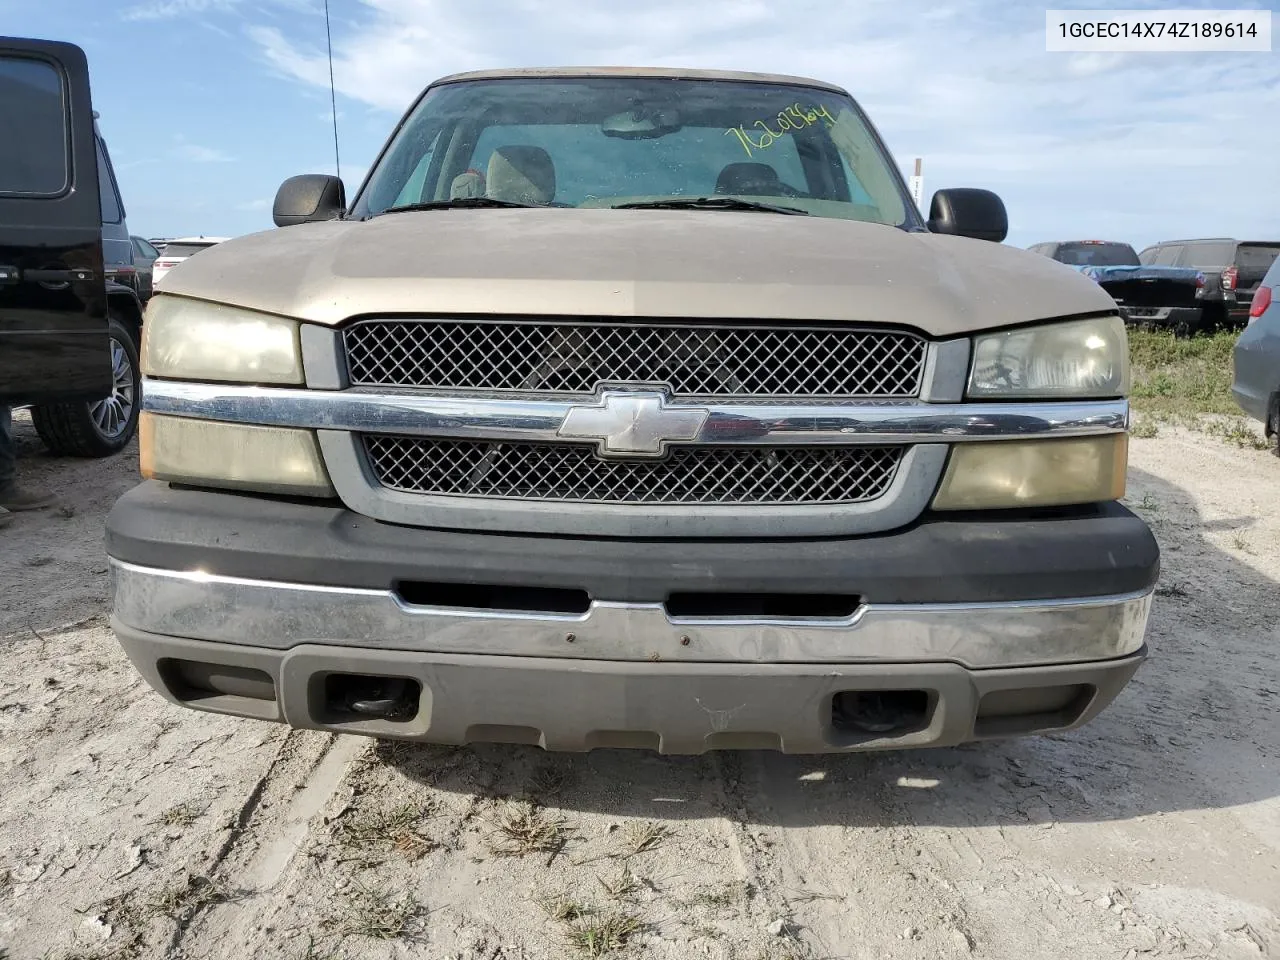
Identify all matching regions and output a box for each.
[142,294,303,384]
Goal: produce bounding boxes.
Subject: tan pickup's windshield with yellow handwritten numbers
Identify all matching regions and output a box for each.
[352,77,915,225]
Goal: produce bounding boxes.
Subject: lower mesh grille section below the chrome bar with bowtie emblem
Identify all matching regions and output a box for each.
[364,434,904,504]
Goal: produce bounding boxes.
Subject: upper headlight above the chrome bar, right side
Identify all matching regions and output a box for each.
[968,316,1129,399]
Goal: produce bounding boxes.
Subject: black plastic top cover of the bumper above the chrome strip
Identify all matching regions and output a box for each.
[106,481,1160,603]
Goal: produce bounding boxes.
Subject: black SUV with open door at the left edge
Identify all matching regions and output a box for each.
[0,37,142,457]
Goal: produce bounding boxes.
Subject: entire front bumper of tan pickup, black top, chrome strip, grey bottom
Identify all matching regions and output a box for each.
[108,483,1158,753]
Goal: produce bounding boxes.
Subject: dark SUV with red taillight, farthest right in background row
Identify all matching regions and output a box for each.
[1138,237,1280,329]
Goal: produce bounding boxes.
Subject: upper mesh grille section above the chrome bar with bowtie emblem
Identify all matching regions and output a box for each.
[343,320,925,398]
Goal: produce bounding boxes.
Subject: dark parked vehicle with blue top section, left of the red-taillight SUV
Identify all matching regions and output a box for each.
[1028,241,1204,334]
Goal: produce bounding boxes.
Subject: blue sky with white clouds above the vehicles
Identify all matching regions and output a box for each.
[0,0,1280,247]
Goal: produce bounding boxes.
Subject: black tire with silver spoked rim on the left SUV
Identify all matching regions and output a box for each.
[31,314,142,457]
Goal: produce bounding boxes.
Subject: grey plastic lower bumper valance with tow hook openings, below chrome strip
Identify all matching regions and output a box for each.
[115,622,1146,754]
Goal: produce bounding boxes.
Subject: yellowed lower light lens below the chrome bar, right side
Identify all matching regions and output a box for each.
[933,434,1129,509]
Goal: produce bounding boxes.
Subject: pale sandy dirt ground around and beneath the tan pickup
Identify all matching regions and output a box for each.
[0,422,1280,960]
